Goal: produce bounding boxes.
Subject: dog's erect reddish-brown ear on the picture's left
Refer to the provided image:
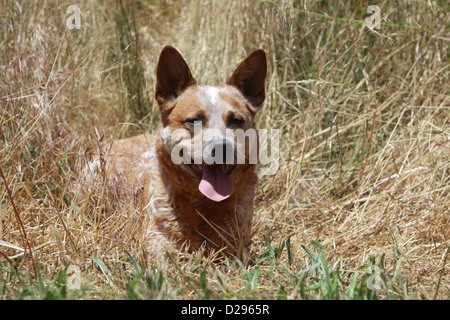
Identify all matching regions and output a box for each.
[155,46,197,106]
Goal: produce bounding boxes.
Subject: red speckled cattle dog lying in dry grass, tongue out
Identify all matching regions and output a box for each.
[77,46,267,259]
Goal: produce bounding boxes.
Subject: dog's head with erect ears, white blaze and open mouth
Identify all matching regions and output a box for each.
[155,46,267,202]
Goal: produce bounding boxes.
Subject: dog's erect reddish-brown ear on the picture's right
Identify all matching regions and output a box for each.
[227,49,267,109]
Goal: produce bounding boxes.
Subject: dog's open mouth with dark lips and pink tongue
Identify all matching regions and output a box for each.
[187,163,236,202]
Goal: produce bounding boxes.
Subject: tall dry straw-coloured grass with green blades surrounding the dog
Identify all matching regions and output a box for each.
[0,0,450,299]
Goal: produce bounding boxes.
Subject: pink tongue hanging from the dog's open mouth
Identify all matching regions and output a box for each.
[198,165,234,202]
